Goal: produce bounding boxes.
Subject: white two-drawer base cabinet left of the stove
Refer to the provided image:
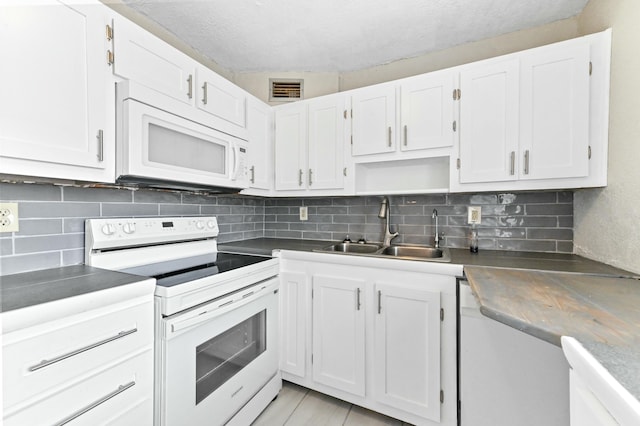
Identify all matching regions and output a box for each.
[2,294,153,426]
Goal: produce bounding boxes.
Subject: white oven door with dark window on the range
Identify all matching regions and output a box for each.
[156,278,278,426]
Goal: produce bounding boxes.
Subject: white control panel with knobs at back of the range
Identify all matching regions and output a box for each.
[85,216,219,250]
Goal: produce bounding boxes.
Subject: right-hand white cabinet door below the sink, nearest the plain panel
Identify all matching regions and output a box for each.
[374,282,441,422]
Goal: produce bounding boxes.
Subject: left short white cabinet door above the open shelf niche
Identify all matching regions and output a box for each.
[351,86,396,155]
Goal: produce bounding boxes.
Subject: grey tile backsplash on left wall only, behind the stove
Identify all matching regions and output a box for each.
[0,183,264,275]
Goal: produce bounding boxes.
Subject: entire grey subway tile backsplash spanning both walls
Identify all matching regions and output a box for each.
[0,183,573,275]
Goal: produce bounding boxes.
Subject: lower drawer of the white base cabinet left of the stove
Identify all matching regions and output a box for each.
[4,349,153,426]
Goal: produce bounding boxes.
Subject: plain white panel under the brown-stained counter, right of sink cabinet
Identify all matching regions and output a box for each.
[459,281,569,426]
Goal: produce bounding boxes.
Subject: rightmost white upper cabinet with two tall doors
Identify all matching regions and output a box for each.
[451,31,611,191]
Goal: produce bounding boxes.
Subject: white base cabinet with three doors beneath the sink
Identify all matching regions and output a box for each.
[280,251,461,426]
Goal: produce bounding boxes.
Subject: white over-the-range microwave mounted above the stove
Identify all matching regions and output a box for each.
[117,99,248,188]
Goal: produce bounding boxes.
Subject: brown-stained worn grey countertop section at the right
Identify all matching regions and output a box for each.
[465,266,640,400]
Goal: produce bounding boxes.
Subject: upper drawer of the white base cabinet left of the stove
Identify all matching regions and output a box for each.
[2,296,153,408]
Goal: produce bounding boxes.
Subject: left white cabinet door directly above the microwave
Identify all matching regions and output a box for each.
[113,17,196,105]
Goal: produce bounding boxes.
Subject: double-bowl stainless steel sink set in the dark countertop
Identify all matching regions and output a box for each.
[314,243,451,262]
